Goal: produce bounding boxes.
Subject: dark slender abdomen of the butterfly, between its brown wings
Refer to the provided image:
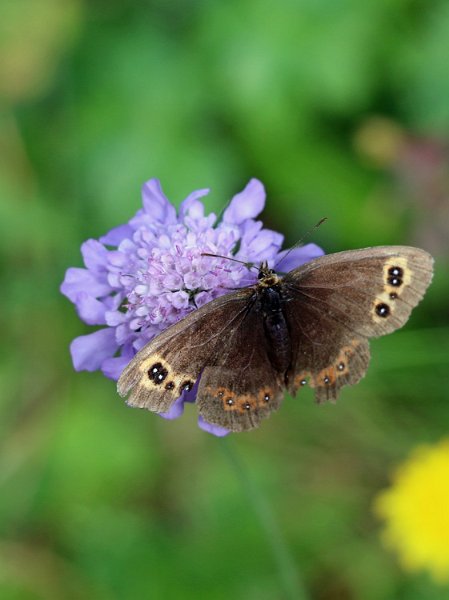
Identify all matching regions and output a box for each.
[259,286,292,376]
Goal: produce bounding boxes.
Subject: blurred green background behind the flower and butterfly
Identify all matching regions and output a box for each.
[0,0,449,600]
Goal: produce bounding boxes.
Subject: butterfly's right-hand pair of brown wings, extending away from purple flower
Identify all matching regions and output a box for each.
[283,246,433,401]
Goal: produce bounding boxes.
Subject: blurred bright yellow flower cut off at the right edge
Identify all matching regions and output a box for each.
[375,439,449,582]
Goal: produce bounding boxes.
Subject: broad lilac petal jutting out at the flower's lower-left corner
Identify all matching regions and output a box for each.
[70,328,117,371]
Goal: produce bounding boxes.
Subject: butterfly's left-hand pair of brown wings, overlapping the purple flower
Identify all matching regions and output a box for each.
[117,288,282,431]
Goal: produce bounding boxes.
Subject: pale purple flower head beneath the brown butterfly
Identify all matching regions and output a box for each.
[61,179,323,435]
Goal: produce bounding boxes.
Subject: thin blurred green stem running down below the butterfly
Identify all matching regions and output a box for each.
[220,438,308,600]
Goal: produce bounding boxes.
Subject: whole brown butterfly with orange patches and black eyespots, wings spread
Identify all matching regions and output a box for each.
[118,246,433,431]
